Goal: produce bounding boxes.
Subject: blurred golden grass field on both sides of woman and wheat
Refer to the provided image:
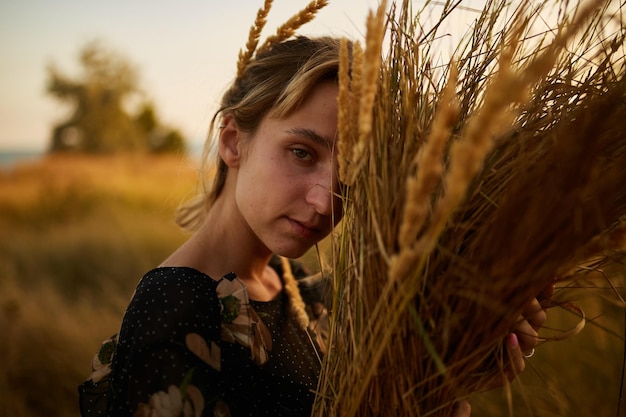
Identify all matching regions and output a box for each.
[0,156,626,417]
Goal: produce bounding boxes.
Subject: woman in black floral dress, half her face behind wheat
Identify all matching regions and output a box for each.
[81,37,545,416]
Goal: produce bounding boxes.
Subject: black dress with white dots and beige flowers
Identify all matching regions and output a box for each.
[79,260,321,417]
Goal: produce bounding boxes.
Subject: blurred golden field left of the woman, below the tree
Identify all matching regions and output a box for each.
[0,156,195,417]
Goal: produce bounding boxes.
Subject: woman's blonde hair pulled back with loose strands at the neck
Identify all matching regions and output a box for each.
[176,36,340,231]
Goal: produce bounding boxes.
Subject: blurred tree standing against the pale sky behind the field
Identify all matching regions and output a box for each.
[47,41,185,153]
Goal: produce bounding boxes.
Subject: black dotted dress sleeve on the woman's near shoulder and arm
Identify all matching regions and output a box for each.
[108,269,222,416]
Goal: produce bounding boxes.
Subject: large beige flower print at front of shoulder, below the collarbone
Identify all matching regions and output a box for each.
[216,273,272,365]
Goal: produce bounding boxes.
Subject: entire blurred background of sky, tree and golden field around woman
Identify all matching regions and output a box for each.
[0,0,626,417]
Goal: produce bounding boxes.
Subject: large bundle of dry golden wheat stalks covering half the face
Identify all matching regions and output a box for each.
[314,0,626,417]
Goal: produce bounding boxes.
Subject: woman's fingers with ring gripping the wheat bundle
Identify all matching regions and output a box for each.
[506,284,554,381]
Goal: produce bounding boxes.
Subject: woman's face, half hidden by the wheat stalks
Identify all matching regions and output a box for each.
[235,82,341,258]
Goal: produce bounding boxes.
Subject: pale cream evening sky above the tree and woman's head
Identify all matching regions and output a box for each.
[0,0,386,151]
